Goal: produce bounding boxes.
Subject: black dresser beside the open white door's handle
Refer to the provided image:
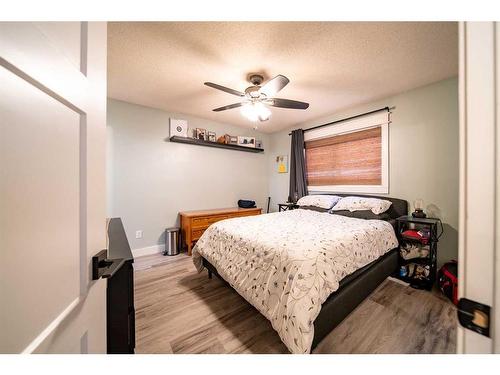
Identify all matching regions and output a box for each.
[106,218,135,354]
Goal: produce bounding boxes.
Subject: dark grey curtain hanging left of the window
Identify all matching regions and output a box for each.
[288,129,307,200]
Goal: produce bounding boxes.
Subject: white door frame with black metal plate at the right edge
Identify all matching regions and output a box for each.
[457,22,500,353]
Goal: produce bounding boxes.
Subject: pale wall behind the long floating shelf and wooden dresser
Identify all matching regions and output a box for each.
[107,99,269,254]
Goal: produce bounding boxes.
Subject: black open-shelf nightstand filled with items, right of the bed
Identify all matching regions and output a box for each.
[396,216,443,290]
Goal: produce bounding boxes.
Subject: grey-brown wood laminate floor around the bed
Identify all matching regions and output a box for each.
[134,253,457,353]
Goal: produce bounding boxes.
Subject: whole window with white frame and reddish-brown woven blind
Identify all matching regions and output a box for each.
[304,112,389,193]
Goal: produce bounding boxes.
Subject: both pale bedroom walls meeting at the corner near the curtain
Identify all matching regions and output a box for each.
[107,78,458,264]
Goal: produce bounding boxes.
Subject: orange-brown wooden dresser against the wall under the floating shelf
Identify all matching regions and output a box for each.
[179,207,262,255]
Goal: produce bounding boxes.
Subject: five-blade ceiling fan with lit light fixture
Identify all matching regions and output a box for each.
[205,74,309,121]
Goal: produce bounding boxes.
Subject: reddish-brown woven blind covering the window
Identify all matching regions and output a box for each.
[305,126,382,186]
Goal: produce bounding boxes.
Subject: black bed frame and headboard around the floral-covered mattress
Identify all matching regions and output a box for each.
[198,194,408,349]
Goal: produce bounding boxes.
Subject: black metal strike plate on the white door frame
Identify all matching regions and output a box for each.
[457,298,491,337]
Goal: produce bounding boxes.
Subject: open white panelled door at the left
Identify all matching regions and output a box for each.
[0,22,106,353]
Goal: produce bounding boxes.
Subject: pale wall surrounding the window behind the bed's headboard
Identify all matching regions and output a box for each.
[268,78,458,264]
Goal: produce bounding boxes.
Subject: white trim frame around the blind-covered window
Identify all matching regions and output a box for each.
[304,112,390,194]
